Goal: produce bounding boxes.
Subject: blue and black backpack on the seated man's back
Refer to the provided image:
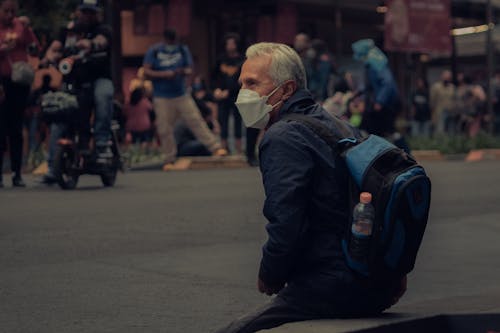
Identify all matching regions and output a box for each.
[284,114,431,281]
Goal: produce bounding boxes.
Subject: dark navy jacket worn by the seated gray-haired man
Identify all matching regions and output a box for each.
[259,90,394,311]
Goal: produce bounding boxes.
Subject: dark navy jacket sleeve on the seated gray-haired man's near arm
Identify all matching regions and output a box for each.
[259,123,313,286]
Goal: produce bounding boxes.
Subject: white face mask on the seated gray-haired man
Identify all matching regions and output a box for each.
[235,84,281,129]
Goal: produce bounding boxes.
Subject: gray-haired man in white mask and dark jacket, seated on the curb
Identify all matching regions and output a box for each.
[217,43,406,333]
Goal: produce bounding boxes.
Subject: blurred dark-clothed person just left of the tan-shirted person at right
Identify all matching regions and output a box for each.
[411,77,431,137]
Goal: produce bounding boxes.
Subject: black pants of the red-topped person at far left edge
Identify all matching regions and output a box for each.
[0,78,30,175]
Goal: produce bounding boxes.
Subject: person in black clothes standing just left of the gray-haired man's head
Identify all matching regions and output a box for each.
[213,33,244,154]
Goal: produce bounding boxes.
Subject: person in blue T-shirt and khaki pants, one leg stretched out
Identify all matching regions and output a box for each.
[144,29,227,171]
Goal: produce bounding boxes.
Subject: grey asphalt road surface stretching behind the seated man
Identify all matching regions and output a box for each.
[0,162,500,333]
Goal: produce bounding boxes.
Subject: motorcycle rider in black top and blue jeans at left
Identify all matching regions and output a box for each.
[41,0,115,185]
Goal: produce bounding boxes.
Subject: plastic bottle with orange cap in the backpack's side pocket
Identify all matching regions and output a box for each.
[349,192,375,263]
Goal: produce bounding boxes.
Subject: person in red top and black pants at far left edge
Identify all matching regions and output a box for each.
[0,0,39,187]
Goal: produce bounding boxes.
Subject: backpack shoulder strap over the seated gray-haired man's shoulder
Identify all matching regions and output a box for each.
[282,113,358,153]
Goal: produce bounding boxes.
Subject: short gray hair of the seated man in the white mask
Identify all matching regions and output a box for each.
[246,43,307,89]
